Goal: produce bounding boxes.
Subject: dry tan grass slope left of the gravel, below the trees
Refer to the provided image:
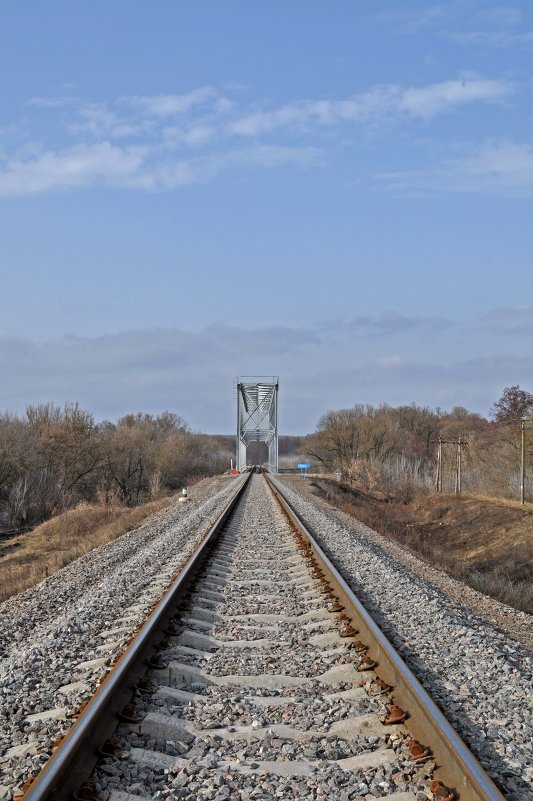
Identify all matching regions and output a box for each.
[0,496,179,601]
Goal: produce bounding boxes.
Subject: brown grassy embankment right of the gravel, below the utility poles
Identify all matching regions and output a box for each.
[314,480,533,614]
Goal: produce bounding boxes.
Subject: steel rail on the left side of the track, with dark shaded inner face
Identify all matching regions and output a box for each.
[23,471,253,801]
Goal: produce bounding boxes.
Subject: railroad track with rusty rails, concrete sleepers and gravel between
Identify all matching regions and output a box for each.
[21,474,503,801]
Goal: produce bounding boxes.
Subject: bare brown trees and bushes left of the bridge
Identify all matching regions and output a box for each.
[0,403,230,528]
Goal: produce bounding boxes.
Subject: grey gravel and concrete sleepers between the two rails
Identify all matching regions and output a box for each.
[93,476,434,801]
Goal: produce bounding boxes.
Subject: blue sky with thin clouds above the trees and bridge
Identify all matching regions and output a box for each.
[0,0,533,433]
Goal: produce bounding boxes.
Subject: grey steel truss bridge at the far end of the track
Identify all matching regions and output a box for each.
[235,376,279,473]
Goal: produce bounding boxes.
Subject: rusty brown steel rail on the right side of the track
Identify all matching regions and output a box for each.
[264,473,505,801]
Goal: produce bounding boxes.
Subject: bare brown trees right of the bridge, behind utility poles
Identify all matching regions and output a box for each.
[302,386,533,500]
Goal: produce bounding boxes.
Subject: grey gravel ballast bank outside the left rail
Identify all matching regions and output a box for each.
[0,477,245,798]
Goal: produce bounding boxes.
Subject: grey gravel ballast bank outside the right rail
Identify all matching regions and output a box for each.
[275,478,533,801]
